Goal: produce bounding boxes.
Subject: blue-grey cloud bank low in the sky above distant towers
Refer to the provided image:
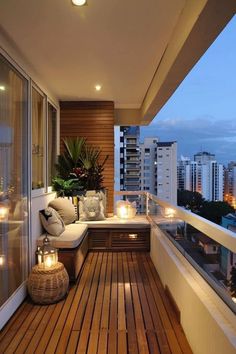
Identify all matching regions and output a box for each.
[141,116,236,164]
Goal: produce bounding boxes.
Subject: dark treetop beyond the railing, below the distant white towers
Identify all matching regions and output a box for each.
[177,190,204,213]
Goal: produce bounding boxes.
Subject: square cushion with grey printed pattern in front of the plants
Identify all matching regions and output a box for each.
[79,193,105,221]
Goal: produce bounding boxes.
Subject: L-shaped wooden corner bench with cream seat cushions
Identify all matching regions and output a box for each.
[37,216,150,281]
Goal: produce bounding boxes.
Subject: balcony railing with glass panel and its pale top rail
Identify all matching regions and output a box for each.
[115,191,236,313]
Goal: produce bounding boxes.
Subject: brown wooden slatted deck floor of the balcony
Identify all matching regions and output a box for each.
[0,252,191,354]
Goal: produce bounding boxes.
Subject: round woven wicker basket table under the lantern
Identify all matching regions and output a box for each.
[28,262,69,304]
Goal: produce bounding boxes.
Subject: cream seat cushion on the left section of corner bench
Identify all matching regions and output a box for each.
[37,224,88,248]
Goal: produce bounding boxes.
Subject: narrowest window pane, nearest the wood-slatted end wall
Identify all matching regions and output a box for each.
[47,103,57,186]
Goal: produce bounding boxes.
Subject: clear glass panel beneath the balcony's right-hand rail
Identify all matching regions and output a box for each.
[148,196,236,313]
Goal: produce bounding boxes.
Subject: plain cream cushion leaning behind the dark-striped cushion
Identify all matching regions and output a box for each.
[48,198,76,225]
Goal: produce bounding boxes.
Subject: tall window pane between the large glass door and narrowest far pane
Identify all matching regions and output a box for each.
[32,88,44,189]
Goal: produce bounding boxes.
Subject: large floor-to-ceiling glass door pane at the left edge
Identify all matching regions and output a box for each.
[0,55,28,306]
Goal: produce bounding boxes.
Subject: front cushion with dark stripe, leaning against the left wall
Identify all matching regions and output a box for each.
[39,207,65,236]
